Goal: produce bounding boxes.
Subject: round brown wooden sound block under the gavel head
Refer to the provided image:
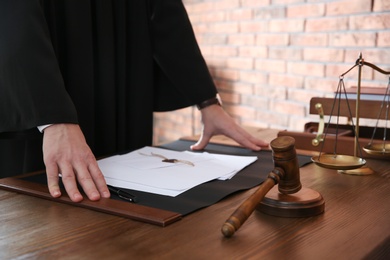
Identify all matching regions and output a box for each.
[256,185,325,218]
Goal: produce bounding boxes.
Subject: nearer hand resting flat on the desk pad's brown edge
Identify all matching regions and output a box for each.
[43,124,110,202]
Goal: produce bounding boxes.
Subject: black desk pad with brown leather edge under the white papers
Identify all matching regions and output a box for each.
[0,140,311,226]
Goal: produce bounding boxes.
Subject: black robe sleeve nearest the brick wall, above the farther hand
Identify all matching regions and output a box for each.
[151,0,217,111]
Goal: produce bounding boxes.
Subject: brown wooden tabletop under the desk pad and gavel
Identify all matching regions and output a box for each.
[0,129,390,259]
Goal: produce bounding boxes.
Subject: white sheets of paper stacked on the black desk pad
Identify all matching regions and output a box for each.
[98,147,257,197]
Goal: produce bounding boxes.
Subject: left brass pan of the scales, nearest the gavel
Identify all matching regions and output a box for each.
[311,154,366,170]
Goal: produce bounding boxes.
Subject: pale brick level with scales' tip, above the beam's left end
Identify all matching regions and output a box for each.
[303,47,344,62]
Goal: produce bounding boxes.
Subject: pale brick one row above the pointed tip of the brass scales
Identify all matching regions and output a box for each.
[329,32,376,48]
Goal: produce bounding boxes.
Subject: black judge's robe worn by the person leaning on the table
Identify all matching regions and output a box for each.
[0,0,216,175]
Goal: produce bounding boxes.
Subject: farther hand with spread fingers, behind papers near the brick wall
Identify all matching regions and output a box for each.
[191,105,269,151]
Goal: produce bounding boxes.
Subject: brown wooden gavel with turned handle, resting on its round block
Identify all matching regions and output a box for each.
[221,136,302,237]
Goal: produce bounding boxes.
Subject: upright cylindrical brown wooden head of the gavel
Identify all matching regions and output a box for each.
[270,136,302,194]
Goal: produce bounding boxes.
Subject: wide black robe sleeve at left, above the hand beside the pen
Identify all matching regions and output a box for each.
[0,0,77,132]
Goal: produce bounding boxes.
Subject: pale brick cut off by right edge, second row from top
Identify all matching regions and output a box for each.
[349,13,390,30]
